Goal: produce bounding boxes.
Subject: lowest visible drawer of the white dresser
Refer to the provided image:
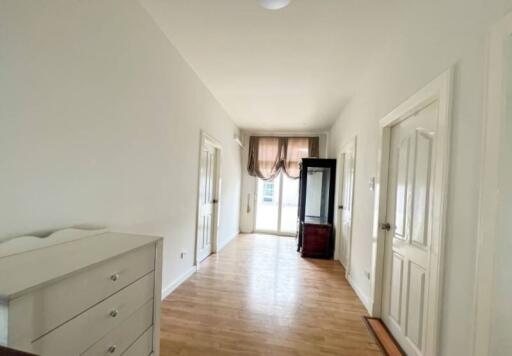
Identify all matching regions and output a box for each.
[82,300,153,356]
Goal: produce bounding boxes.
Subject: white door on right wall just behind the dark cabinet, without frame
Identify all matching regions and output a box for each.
[338,139,356,274]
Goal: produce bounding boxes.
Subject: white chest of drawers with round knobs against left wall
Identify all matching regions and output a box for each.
[0,232,162,356]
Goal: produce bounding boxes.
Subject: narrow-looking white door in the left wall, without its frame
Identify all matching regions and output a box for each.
[197,141,217,262]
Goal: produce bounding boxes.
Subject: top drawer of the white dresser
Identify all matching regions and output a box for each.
[9,244,155,345]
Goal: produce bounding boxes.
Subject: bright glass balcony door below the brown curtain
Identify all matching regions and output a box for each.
[255,173,299,235]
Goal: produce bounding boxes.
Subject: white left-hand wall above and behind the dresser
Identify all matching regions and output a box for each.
[0,0,241,294]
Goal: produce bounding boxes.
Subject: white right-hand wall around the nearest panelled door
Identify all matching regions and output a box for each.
[330,0,512,355]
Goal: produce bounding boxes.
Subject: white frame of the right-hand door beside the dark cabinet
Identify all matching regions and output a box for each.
[334,136,357,279]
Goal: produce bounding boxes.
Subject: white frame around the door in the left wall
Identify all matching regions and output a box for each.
[194,130,222,267]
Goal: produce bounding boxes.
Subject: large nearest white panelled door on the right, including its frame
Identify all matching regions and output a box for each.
[371,70,453,356]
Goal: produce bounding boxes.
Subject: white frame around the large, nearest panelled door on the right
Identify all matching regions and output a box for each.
[370,69,453,355]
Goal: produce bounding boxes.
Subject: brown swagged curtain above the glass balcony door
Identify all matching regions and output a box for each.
[247,136,319,180]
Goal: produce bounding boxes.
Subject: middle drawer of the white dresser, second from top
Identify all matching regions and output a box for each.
[32,273,154,356]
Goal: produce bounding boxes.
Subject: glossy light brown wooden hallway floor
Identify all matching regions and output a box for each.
[161,235,381,356]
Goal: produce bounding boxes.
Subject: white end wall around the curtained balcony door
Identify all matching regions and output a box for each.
[240,131,329,233]
